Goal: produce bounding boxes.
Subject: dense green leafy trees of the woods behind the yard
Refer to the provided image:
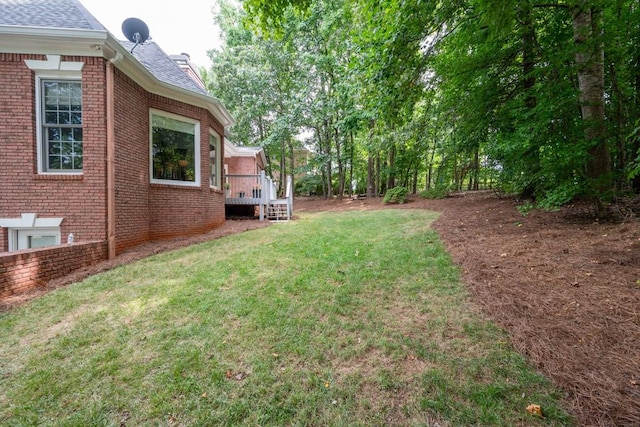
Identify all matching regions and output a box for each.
[206,0,640,207]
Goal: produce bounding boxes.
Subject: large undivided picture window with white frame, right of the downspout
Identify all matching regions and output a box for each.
[150,110,200,186]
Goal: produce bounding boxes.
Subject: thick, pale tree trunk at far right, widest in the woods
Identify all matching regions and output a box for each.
[571,0,611,192]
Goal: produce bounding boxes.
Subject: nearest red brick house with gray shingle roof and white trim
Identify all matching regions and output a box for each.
[0,0,233,294]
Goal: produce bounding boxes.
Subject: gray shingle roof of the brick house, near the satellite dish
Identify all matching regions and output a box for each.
[0,0,210,96]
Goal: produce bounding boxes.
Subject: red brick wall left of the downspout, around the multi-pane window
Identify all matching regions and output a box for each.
[0,53,106,252]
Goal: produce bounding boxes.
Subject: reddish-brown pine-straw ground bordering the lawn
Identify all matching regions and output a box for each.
[0,192,640,426]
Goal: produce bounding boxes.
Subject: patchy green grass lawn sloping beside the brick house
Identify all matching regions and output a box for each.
[0,210,572,426]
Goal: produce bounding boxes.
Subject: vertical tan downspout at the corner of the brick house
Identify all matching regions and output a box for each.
[106,57,119,259]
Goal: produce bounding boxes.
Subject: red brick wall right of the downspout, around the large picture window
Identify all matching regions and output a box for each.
[115,70,224,253]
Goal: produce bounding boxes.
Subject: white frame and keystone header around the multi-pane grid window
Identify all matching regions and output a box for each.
[25,55,86,175]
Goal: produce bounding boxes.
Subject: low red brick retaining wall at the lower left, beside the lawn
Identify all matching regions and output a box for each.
[0,242,107,299]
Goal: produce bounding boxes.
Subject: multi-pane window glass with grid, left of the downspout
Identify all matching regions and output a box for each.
[40,79,83,172]
